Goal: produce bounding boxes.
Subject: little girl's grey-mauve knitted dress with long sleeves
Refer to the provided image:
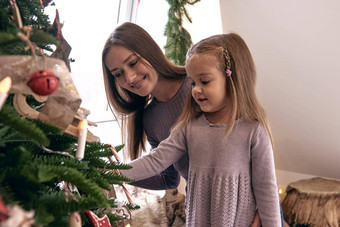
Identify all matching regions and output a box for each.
[122,115,281,227]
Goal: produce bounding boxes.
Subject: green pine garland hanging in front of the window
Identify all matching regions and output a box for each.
[164,0,200,65]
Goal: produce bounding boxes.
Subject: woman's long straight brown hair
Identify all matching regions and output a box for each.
[102,22,186,159]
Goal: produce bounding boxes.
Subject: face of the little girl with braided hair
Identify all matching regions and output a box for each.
[186,54,228,123]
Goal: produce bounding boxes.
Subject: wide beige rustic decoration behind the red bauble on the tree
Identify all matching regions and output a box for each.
[0,55,81,129]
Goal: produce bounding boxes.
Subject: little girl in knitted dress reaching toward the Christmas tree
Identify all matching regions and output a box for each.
[122,34,281,227]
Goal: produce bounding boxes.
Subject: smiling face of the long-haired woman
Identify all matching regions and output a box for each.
[105,46,158,96]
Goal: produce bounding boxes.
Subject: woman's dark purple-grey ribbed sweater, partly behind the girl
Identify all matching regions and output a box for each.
[131,77,190,190]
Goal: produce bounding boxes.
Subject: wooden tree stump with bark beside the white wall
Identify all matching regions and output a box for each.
[282,177,340,227]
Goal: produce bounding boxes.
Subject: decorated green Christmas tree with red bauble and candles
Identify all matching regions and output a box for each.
[0,0,138,227]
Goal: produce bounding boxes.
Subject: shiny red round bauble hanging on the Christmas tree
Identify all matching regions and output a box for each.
[27,69,59,96]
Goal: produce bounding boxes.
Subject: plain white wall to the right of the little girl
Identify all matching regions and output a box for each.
[220,0,340,183]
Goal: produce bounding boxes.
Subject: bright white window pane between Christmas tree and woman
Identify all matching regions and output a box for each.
[45,0,121,145]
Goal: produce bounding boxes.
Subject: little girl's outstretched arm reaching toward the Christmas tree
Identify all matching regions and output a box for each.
[121,129,187,181]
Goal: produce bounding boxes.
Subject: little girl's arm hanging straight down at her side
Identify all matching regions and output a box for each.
[251,126,281,227]
